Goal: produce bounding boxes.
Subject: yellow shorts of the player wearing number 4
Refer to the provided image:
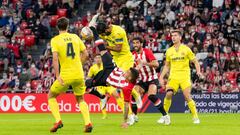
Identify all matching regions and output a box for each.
[50,79,86,96]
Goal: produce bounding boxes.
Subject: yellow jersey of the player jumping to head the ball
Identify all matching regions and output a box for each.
[100,25,132,61]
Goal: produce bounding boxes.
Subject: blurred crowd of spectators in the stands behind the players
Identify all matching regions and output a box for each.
[0,0,240,93]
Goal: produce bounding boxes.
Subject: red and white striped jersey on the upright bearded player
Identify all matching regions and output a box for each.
[133,48,158,82]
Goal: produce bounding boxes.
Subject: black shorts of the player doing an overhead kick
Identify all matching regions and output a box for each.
[85,52,116,88]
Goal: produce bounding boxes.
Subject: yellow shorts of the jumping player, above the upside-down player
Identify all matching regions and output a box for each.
[114,56,134,71]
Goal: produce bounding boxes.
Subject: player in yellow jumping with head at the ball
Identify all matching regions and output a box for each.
[96,19,142,125]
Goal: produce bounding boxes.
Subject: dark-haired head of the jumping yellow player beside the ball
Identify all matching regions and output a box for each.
[96,18,112,36]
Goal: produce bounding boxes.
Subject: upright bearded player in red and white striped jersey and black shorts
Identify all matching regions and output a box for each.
[132,37,170,125]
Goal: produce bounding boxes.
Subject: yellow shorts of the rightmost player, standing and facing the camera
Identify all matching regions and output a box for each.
[167,79,192,93]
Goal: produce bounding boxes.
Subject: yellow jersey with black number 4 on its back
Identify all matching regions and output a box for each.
[51,32,86,79]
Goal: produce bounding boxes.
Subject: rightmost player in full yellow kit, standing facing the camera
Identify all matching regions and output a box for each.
[158,30,202,124]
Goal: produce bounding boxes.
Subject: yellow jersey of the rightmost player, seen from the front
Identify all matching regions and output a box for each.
[166,44,195,79]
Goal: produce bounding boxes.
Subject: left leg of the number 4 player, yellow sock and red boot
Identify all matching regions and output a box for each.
[48,80,68,132]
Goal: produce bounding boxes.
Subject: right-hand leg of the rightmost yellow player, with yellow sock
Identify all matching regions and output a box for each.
[180,80,200,124]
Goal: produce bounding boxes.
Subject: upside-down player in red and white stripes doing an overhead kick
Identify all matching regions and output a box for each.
[86,39,139,128]
